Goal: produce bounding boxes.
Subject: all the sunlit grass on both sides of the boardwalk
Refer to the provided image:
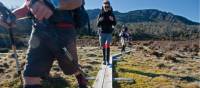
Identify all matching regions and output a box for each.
[0,42,200,88]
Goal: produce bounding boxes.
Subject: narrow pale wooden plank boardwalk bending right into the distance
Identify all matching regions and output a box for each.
[92,50,132,88]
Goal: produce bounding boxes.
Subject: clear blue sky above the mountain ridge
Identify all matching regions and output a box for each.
[0,0,200,23]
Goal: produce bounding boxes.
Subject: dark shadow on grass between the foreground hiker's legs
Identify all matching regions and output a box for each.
[42,77,70,88]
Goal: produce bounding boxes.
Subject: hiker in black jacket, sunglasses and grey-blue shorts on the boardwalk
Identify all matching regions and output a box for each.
[97,0,116,65]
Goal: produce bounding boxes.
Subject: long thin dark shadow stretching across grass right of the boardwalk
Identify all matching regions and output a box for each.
[119,68,200,82]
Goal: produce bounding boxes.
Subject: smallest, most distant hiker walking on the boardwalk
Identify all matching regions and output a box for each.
[119,25,129,52]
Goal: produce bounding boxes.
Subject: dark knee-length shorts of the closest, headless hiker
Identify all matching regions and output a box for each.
[23,22,78,77]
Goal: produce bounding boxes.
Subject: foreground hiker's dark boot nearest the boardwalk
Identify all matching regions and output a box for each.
[76,74,87,88]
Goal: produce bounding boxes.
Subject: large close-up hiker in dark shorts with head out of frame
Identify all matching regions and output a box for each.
[1,0,87,88]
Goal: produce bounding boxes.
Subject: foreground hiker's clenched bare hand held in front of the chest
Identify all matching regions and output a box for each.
[30,1,53,21]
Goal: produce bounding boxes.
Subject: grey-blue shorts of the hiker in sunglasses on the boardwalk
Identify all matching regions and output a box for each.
[99,33,112,47]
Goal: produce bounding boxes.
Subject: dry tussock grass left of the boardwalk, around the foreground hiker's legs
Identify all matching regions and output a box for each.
[0,47,102,88]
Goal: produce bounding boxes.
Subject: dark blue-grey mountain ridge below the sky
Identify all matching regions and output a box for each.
[87,9,200,25]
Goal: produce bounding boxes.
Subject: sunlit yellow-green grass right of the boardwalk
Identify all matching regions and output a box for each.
[114,47,200,88]
